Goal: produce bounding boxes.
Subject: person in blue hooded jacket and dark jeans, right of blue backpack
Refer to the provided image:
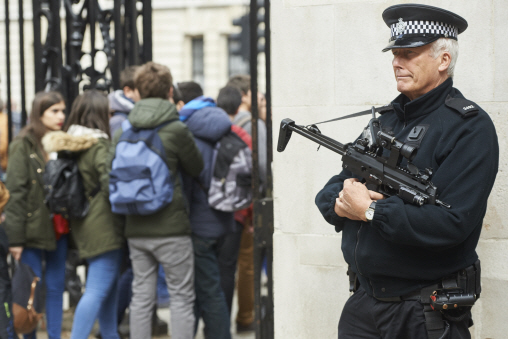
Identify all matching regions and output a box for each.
[178,82,235,339]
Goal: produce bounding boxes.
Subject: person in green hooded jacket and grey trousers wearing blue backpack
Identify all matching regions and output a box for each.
[111,62,203,339]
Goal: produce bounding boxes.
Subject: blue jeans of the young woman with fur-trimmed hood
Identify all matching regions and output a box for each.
[71,249,122,339]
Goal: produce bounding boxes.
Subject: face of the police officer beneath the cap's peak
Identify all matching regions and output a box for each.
[392,44,447,100]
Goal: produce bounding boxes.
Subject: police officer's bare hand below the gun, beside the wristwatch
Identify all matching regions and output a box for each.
[334,178,376,221]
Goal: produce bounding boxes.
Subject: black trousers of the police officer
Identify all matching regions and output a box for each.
[339,287,471,339]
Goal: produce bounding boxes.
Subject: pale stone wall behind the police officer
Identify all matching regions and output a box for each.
[271,0,508,339]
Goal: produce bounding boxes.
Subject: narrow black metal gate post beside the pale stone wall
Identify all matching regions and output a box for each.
[249,0,274,339]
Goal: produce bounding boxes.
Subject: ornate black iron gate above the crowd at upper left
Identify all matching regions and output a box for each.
[4,0,152,141]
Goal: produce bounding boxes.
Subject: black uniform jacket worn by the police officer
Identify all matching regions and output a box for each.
[316,78,499,297]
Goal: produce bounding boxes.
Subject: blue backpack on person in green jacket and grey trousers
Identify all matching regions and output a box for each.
[109,120,173,215]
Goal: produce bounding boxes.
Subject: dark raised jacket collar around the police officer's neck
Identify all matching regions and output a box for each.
[392,78,453,122]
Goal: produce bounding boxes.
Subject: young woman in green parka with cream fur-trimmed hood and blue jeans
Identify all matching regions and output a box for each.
[43,90,124,339]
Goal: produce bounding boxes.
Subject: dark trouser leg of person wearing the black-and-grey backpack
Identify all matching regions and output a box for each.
[217,221,243,314]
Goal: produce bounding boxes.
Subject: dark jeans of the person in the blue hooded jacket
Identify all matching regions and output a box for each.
[192,234,231,339]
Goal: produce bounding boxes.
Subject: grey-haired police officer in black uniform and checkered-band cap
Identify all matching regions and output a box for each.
[316,4,499,339]
